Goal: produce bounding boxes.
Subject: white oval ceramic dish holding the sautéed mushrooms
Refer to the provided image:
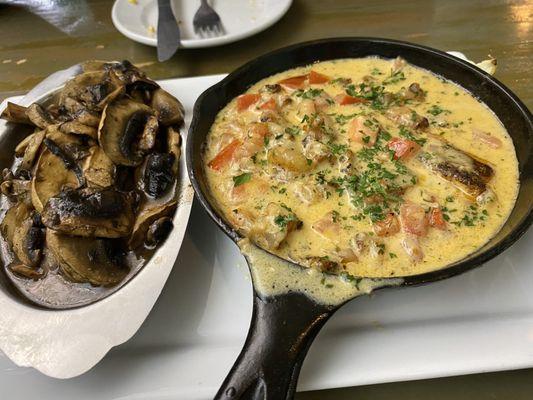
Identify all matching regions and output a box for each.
[0,69,194,378]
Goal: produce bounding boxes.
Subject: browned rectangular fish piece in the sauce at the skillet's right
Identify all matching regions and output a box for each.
[417,139,494,198]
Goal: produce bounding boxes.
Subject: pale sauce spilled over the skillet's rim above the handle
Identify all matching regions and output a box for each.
[238,239,403,306]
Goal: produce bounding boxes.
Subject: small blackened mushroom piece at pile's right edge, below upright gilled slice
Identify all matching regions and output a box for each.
[143,153,175,199]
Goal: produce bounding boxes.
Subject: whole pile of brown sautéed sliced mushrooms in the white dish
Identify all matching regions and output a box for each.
[0,61,183,290]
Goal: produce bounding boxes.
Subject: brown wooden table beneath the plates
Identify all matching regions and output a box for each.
[0,0,533,400]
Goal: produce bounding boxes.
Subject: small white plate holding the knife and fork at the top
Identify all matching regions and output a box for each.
[111,0,292,48]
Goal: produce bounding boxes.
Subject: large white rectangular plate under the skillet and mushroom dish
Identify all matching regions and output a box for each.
[0,76,533,400]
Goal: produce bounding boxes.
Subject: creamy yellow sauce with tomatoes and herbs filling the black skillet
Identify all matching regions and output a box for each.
[204,58,518,280]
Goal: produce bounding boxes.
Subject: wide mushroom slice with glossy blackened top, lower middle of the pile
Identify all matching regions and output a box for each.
[42,188,135,238]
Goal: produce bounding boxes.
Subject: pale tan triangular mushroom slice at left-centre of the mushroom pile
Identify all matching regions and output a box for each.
[31,149,78,212]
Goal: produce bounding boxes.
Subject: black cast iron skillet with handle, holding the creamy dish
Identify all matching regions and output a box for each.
[186,38,533,400]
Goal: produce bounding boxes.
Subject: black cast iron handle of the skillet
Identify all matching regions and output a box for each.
[215,293,336,400]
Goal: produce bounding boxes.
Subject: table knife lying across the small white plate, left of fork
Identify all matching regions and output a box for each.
[157,0,180,62]
